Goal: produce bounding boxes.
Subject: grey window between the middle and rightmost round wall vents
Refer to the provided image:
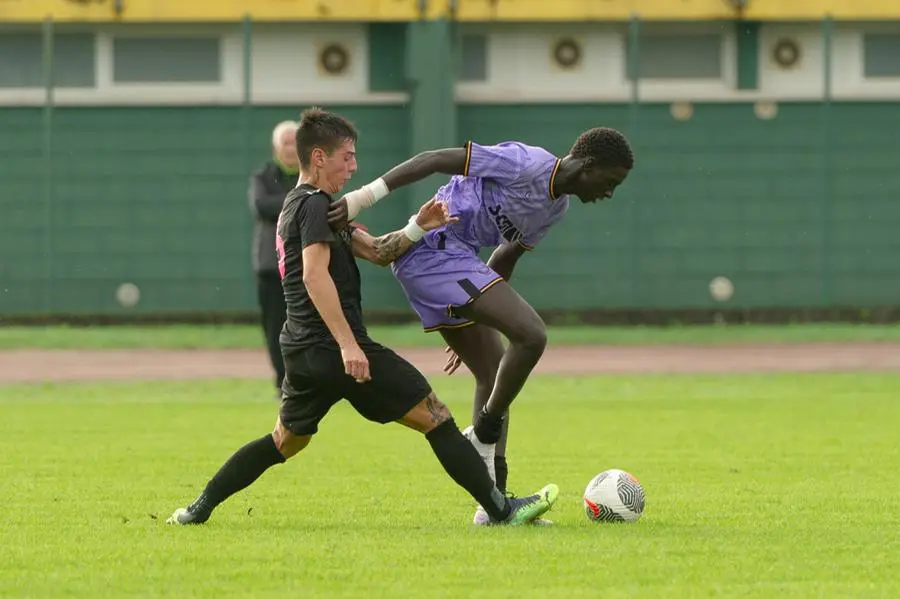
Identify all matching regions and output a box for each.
[625,34,722,80]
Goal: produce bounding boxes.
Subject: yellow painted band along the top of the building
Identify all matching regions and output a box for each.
[0,0,900,23]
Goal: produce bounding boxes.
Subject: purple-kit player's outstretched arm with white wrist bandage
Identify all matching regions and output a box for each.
[328,148,468,229]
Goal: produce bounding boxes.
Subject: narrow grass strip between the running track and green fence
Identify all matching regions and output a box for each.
[0,324,900,350]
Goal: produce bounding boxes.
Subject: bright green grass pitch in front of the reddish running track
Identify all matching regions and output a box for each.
[0,374,900,599]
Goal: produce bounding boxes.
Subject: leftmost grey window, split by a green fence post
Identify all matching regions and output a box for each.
[0,33,95,88]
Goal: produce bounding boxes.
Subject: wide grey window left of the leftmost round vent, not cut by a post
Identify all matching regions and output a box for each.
[113,37,222,83]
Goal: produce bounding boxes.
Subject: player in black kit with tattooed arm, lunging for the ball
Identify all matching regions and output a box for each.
[167,108,559,525]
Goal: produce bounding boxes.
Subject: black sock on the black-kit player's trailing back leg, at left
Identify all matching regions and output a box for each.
[193,435,285,511]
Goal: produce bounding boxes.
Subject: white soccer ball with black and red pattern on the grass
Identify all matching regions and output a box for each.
[584,469,644,522]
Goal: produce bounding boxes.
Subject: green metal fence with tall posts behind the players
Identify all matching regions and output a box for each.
[0,20,900,316]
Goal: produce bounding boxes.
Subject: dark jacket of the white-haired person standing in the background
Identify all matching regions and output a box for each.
[247,160,298,274]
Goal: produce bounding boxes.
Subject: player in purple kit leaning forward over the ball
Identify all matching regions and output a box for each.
[329,127,634,523]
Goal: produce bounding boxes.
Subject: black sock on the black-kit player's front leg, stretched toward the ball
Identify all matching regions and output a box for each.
[425,418,510,520]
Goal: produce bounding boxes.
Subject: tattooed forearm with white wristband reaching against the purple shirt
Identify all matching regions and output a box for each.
[350,198,458,266]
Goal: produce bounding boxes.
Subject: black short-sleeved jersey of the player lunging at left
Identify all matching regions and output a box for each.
[275,184,367,352]
